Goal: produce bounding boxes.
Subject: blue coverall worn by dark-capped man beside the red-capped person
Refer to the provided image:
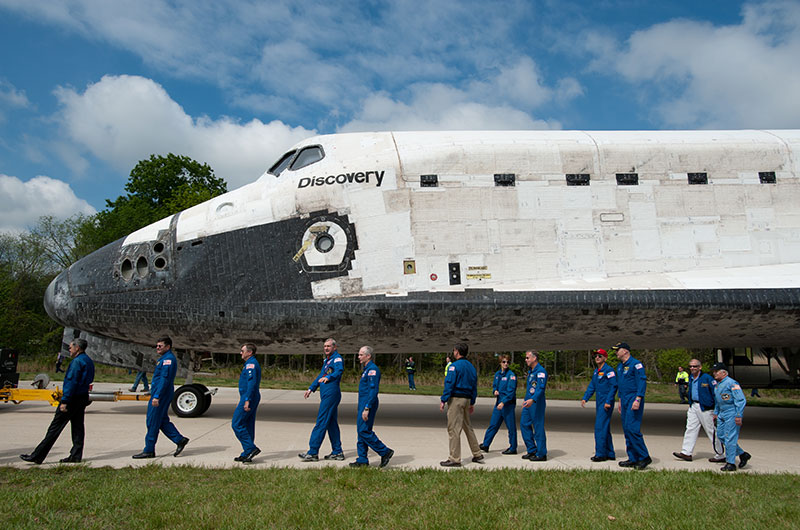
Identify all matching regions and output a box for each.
[617,357,650,462]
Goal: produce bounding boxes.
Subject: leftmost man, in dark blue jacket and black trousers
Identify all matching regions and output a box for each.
[19,339,94,464]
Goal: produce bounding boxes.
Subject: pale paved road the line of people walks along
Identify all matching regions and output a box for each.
[0,383,800,473]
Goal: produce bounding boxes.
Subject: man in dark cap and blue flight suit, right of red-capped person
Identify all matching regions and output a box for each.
[611,342,653,470]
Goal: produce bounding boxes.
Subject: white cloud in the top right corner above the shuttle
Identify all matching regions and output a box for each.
[596,1,800,128]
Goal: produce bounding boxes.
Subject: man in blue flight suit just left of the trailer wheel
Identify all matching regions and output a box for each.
[133,337,189,459]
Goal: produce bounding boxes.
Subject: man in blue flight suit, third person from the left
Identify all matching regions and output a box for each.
[231,343,261,463]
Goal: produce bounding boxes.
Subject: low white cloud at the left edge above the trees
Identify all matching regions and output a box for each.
[0,174,95,232]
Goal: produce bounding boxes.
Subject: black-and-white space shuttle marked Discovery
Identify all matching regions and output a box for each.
[44,130,800,376]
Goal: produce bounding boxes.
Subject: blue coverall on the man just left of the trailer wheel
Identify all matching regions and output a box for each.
[143,349,183,453]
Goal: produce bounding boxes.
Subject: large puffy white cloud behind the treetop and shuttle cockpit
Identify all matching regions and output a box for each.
[56,76,315,189]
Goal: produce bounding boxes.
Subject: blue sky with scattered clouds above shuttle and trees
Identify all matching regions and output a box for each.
[0,0,800,231]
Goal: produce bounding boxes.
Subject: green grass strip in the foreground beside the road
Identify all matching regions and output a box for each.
[0,465,800,529]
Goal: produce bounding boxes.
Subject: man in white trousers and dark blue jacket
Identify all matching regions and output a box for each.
[672,359,725,462]
